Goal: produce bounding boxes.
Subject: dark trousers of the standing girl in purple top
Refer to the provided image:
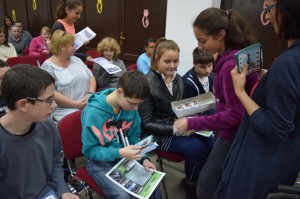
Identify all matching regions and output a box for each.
[197,138,231,199]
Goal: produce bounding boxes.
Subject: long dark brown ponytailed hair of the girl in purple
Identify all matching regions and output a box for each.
[193,8,257,50]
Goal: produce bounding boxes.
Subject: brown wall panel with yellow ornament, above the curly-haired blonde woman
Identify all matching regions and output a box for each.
[84,0,124,48]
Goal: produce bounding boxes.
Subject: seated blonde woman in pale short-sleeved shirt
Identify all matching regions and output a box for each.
[41,30,96,121]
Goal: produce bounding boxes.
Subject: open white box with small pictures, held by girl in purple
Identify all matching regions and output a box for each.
[171,92,217,118]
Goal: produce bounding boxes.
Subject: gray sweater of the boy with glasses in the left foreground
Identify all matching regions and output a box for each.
[0,119,69,199]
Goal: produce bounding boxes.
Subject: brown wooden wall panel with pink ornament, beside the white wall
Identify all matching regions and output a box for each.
[123,0,167,65]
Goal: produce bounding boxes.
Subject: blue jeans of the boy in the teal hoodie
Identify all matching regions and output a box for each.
[85,158,162,199]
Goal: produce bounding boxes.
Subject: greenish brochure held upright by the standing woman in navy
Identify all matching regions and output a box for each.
[235,44,262,75]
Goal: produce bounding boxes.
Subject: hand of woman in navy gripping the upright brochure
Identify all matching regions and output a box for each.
[231,64,248,97]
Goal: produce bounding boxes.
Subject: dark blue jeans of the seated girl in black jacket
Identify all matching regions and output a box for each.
[162,135,215,182]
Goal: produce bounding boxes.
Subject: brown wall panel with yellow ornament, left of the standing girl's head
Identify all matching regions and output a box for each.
[27,0,52,37]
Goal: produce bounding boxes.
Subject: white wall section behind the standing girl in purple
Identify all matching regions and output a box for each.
[166,0,221,75]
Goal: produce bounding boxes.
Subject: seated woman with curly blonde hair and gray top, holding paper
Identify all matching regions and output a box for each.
[93,37,127,91]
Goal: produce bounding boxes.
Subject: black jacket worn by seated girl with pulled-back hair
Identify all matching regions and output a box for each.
[139,70,183,136]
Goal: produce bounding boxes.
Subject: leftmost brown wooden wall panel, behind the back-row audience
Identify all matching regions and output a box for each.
[5,0,28,30]
